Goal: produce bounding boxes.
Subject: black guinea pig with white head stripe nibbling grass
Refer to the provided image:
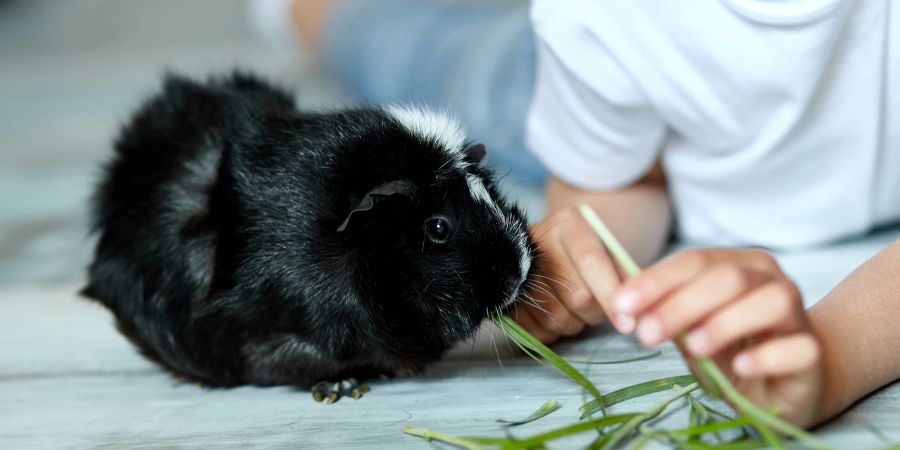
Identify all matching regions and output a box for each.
[82,73,537,402]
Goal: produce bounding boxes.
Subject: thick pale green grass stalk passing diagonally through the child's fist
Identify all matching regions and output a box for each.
[578,203,831,449]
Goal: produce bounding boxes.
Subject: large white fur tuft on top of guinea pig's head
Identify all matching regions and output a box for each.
[384,105,466,158]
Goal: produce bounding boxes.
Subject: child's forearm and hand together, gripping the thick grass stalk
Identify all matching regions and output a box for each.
[612,241,900,426]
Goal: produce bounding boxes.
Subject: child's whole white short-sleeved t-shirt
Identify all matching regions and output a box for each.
[526,0,900,248]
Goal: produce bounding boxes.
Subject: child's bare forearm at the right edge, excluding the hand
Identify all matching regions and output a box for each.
[809,240,900,423]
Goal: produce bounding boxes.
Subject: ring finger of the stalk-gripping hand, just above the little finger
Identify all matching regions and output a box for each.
[687,280,802,356]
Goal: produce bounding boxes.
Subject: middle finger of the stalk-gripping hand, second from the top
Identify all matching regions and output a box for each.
[637,263,764,345]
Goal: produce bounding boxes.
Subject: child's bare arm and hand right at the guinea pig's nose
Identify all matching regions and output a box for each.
[511,170,671,342]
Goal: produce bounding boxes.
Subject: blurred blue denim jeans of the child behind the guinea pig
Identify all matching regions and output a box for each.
[319,0,546,185]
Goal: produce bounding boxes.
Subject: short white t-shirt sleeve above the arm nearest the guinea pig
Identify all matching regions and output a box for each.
[525,0,666,190]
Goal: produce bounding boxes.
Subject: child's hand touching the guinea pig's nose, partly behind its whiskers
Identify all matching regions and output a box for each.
[510,208,621,343]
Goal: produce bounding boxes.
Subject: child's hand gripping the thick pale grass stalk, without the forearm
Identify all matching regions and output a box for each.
[611,249,822,425]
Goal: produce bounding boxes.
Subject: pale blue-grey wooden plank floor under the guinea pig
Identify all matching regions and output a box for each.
[0,0,900,449]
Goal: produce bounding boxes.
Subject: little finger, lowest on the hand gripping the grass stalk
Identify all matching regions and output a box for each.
[731,333,819,378]
